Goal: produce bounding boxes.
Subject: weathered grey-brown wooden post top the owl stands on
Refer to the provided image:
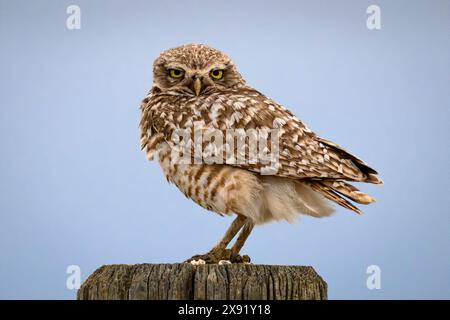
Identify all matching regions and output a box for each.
[77,263,327,300]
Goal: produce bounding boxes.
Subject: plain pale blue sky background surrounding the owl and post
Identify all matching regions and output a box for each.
[0,0,450,299]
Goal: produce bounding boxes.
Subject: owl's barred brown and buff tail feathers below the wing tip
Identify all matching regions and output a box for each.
[308,181,375,214]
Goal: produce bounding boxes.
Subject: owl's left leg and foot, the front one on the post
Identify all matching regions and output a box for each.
[186,215,247,264]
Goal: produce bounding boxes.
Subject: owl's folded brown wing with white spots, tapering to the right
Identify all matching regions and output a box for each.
[202,90,382,183]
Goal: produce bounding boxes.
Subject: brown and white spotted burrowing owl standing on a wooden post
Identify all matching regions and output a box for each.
[140,44,382,263]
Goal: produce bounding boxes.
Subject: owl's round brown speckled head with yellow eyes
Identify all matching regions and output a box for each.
[153,44,245,96]
